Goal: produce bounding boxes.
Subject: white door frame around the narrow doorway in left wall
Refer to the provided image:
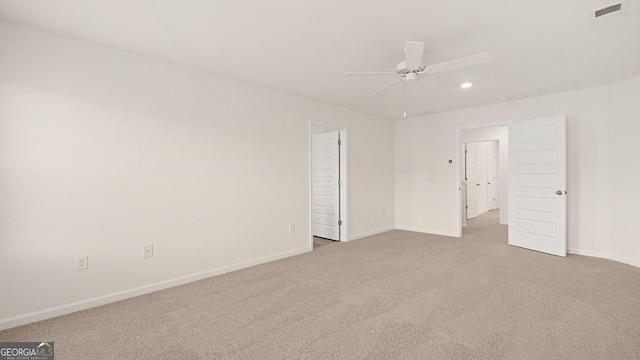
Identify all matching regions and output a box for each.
[308,120,349,251]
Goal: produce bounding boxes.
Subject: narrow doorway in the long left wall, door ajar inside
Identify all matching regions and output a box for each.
[309,121,348,250]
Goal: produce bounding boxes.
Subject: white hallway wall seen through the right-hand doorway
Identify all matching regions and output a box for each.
[459,125,509,224]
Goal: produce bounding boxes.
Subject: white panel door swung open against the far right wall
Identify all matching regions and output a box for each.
[509,115,567,256]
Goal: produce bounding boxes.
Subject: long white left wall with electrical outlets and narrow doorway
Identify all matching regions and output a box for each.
[0,21,395,328]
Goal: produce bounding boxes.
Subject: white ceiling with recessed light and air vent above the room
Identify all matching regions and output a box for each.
[0,0,640,118]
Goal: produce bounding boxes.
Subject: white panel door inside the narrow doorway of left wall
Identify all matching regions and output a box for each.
[311,131,340,240]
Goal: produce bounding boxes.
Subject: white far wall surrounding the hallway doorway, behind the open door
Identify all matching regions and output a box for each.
[396,86,608,260]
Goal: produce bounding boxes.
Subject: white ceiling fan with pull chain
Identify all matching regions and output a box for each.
[344,41,491,117]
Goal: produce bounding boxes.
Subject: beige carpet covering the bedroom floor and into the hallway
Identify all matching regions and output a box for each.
[0,212,640,360]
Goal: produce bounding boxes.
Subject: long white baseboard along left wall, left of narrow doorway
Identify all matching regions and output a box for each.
[0,247,310,330]
